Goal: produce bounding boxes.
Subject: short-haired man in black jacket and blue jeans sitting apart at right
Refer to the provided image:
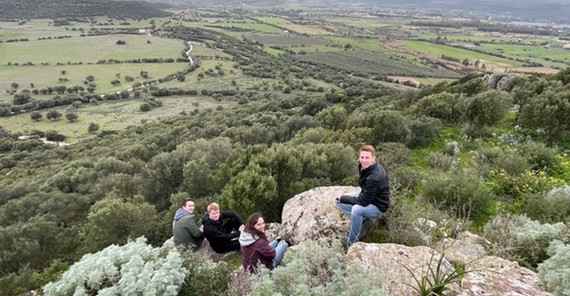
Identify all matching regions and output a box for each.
[335,145,390,245]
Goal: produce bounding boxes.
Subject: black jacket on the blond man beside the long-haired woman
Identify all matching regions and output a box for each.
[202,211,243,253]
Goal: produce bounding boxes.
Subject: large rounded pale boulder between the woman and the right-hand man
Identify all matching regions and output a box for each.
[280,186,360,244]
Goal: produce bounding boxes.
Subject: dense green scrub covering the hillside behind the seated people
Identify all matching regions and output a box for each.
[0,66,570,295]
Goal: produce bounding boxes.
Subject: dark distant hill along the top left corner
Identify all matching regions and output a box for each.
[0,0,170,20]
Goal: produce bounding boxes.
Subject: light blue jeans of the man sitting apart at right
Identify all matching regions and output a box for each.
[334,192,382,245]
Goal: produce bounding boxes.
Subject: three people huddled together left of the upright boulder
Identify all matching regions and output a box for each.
[172,198,290,272]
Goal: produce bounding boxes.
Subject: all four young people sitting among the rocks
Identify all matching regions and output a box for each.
[173,145,390,272]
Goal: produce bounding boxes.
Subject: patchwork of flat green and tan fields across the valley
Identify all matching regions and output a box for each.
[0,14,570,139]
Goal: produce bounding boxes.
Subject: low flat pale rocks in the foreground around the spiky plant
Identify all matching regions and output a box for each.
[346,243,552,296]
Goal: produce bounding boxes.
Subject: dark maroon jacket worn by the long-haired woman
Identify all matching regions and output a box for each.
[239,231,275,273]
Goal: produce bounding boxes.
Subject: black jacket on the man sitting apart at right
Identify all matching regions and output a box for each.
[340,162,390,213]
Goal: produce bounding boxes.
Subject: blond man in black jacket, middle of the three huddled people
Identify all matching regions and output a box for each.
[202,203,245,253]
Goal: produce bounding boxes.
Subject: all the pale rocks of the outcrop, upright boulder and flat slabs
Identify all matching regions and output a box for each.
[282,187,552,296]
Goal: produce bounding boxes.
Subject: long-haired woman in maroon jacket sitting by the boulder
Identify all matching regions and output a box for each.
[239,213,289,273]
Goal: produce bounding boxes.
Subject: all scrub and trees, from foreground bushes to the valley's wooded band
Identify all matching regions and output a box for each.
[0,2,570,295]
